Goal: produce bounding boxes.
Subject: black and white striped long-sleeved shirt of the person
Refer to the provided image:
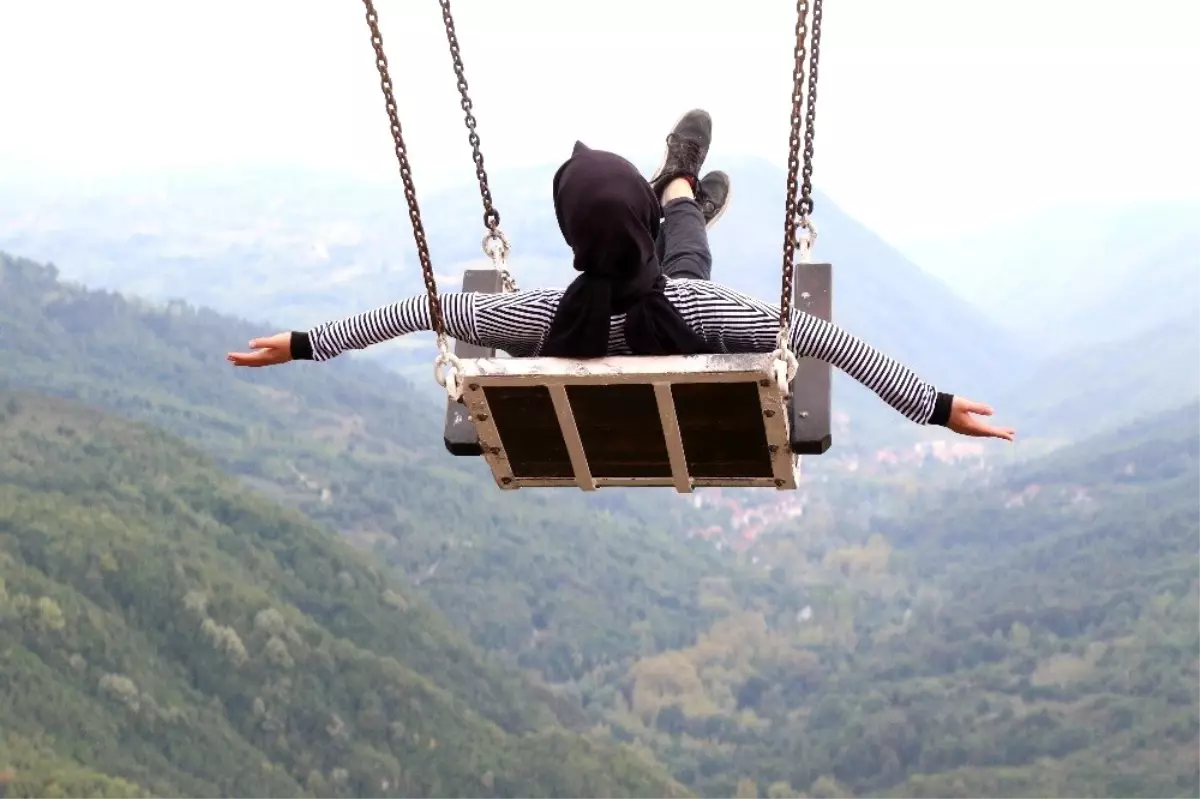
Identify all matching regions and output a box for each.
[304,280,950,425]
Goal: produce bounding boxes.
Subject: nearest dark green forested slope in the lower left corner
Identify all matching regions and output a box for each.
[0,391,682,799]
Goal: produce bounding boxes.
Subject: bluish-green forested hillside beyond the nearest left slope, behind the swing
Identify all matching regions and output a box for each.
[0,256,728,679]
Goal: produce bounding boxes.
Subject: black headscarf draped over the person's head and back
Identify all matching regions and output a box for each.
[541,142,710,358]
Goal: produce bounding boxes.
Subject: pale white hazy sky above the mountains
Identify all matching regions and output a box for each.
[0,0,1200,242]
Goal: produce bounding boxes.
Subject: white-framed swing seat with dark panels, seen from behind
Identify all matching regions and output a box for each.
[453,354,796,493]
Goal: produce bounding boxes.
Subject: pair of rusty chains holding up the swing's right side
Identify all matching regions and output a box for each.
[775,0,822,394]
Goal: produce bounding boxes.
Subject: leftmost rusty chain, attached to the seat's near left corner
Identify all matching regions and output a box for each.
[362,0,461,400]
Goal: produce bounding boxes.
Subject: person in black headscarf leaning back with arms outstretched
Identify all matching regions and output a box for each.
[227,109,1015,441]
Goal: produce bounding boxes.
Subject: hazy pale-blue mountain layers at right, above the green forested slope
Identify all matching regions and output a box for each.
[910,202,1200,439]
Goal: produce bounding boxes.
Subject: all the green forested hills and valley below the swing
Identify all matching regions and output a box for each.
[0,250,1200,799]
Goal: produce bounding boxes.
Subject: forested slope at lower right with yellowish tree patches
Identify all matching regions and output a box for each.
[580,405,1200,799]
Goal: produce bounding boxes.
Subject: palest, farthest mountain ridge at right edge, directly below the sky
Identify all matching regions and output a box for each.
[908,200,1200,354]
